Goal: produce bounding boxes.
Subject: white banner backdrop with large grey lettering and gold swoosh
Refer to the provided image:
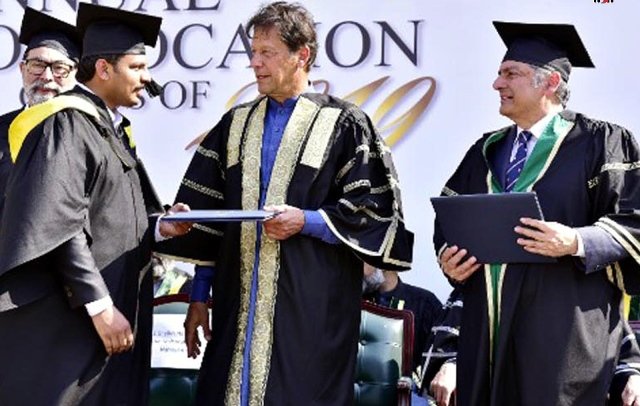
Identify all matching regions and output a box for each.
[0,0,640,299]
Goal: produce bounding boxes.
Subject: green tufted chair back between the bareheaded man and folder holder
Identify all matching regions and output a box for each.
[354,301,413,406]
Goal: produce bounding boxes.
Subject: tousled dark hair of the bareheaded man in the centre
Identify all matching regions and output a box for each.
[247,1,318,72]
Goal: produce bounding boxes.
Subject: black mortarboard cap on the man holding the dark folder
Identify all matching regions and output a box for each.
[493,21,594,81]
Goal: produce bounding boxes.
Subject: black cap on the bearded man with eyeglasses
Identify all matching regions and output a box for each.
[19,7,81,61]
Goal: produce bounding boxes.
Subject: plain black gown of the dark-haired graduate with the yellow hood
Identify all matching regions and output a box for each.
[0,88,159,406]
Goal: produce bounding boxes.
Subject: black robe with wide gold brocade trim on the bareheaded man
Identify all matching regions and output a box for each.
[158,94,413,406]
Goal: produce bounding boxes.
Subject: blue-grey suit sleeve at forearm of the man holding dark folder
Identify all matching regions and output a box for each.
[577,226,629,273]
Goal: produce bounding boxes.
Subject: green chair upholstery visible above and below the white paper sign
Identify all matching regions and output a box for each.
[149,294,198,406]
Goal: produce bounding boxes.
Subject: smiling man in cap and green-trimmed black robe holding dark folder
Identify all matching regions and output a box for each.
[434,22,640,406]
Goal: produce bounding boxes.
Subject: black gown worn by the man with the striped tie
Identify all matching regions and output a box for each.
[434,111,640,406]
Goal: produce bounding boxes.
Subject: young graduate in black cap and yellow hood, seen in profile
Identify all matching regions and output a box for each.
[0,3,186,406]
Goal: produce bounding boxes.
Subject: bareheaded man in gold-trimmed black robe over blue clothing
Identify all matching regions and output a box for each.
[158,2,413,406]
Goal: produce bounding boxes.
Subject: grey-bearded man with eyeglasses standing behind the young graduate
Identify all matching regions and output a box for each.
[0,7,81,203]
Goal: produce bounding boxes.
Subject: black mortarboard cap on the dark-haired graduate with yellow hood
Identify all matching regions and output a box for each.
[76,3,162,56]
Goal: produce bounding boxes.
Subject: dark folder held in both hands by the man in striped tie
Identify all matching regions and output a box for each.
[431,192,556,264]
